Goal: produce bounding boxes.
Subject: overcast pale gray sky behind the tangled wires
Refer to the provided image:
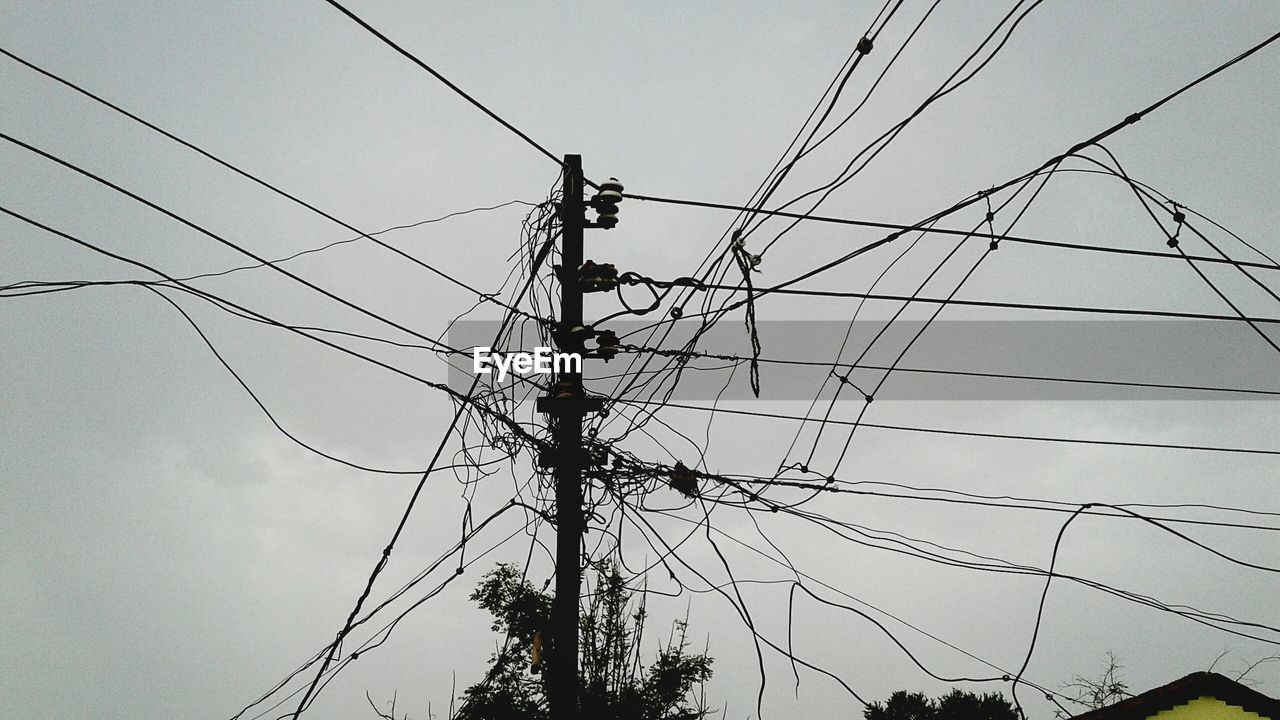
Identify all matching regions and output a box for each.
[0,0,1280,720]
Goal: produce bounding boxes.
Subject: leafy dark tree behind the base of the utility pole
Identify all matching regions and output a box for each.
[454,565,712,720]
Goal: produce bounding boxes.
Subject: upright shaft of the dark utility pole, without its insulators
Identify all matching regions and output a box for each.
[547,155,586,720]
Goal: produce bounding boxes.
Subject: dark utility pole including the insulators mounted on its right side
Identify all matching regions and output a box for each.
[538,155,622,720]
